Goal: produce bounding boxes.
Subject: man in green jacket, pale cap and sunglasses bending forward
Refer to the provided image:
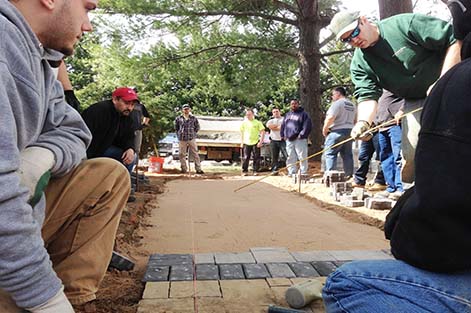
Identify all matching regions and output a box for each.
[329,12,461,182]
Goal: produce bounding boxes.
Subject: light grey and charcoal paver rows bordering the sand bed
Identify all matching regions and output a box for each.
[143,247,391,282]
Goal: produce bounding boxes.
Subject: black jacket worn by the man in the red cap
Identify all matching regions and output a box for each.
[82,100,135,159]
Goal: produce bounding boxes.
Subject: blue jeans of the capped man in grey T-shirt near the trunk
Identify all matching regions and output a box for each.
[324,128,353,176]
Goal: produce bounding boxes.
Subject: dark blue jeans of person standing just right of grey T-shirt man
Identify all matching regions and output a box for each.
[354,132,385,185]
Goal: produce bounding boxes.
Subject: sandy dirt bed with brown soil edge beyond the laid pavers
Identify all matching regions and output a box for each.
[78,162,387,313]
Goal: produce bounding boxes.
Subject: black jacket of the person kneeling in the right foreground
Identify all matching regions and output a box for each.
[385,59,471,272]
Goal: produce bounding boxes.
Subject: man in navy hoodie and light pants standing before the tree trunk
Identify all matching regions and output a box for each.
[280,99,312,176]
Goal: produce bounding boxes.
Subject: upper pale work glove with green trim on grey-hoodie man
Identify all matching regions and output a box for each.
[17,147,55,207]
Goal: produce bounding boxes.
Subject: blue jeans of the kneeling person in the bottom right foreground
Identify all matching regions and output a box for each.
[323,260,471,313]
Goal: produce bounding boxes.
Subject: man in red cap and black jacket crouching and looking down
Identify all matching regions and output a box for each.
[82,87,138,172]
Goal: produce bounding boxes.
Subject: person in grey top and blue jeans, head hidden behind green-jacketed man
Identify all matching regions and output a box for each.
[376,90,404,200]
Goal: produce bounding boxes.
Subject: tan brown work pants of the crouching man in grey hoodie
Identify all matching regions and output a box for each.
[0,158,130,313]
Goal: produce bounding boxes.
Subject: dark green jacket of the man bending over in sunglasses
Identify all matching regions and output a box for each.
[350,13,456,102]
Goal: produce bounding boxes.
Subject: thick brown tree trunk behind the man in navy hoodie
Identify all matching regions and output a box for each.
[298,0,324,159]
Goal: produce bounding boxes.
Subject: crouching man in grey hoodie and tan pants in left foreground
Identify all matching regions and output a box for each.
[0,0,129,313]
